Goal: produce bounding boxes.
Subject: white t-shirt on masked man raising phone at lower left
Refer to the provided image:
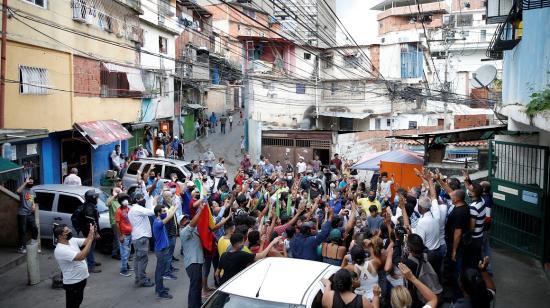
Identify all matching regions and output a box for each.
[54,238,90,284]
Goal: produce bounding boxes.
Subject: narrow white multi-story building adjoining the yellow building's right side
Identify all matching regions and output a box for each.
[138,0,182,148]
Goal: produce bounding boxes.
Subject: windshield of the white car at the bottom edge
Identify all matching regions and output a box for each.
[203,292,304,308]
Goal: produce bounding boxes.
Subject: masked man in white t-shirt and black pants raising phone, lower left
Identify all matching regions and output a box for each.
[54,224,95,307]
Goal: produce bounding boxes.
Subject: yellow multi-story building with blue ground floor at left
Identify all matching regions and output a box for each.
[0,0,145,185]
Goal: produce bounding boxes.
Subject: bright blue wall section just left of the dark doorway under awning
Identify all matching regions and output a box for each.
[40,134,61,184]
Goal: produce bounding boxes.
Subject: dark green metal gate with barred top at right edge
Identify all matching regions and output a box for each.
[489,141,549,260]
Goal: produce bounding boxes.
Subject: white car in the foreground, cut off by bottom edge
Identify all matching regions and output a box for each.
[202,258,340,308]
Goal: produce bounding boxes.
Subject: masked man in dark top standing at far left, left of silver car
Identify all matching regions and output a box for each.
[17,178,38,253]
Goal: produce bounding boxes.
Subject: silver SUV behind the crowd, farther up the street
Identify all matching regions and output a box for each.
[122,158,191,193]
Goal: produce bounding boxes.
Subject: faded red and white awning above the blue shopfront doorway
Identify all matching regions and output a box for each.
[73,120,132,149]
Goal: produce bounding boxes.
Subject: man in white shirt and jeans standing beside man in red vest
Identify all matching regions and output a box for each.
[128,191,156,287]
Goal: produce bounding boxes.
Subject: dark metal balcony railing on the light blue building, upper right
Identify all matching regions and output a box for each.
[486,2,523,59]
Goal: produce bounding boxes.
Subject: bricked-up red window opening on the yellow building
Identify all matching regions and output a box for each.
[73,56,101,96]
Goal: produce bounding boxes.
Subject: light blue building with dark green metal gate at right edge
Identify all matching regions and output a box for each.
[487,0,550,268]
